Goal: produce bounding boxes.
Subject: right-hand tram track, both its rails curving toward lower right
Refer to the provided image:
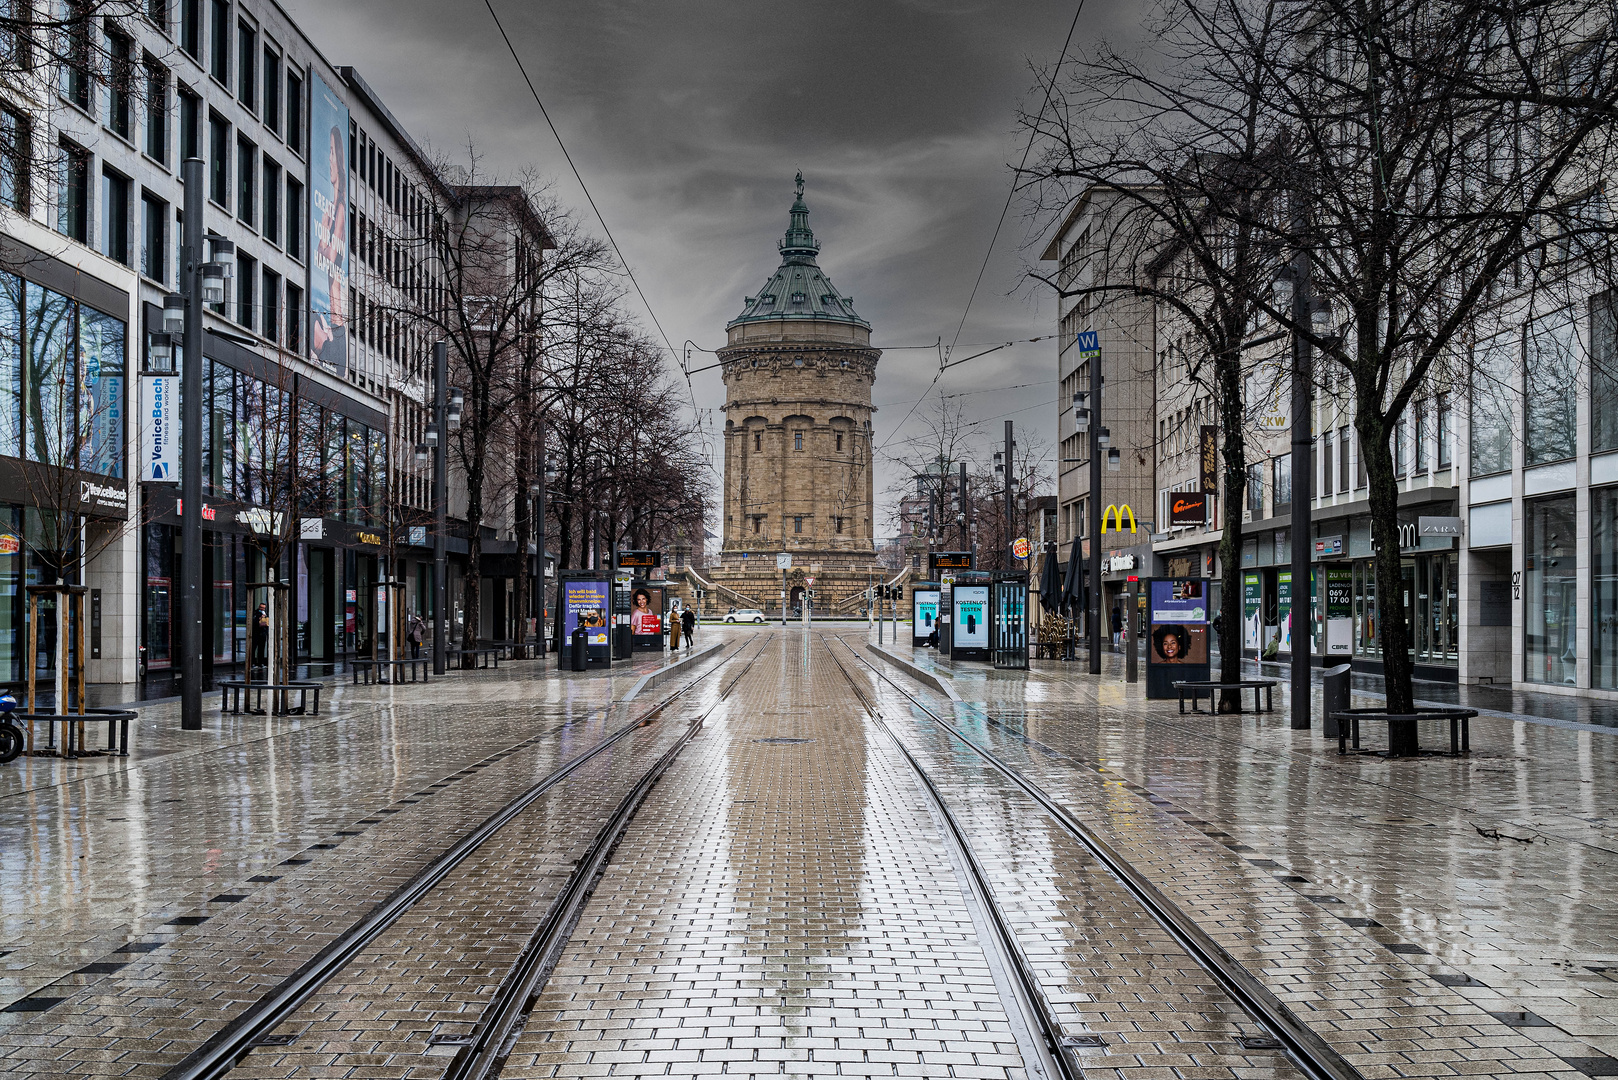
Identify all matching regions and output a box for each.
[827,638,1362,1080]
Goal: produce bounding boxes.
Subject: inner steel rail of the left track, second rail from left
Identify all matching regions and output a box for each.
[443,638,769,1080]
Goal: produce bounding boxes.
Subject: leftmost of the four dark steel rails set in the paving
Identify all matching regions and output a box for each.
[162,634,757,1080]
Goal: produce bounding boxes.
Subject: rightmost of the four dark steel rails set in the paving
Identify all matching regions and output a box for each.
[838,638,1364,1080]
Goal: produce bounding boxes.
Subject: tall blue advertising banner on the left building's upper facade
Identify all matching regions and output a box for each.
[309,71,349,376]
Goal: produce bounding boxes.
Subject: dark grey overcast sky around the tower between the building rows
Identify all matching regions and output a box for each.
[282,0,1137,536]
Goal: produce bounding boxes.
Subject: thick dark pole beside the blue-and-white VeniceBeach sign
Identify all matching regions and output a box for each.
[180,157,205,732]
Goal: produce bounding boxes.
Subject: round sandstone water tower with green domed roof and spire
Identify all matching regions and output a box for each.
[710,175,882,610]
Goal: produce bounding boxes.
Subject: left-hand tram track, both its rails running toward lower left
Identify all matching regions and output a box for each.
[162,635,770,1080]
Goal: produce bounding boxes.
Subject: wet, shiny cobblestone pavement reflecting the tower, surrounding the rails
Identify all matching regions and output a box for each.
[0,625,1618,1080]
